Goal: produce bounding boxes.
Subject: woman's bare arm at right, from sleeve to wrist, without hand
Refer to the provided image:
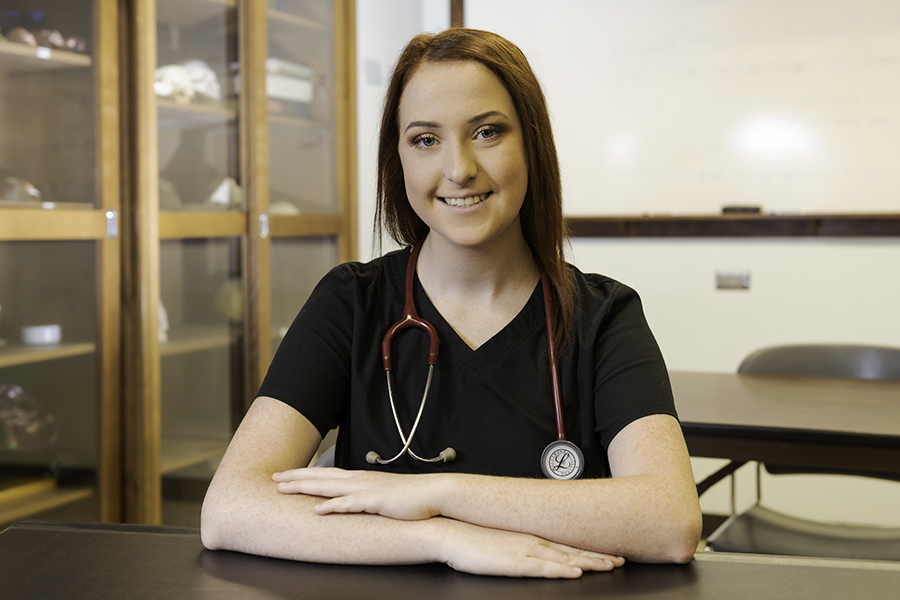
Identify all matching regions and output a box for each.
[436,415,702,562]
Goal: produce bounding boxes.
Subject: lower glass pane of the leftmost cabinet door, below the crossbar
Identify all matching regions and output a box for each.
[0,240,101,524]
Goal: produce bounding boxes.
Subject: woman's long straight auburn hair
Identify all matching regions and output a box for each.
[375,28,575,353]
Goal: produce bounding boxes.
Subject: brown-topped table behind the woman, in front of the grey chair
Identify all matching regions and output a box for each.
[670,371,900,474]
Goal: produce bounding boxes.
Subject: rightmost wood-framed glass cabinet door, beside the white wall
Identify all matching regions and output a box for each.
[264,0,355,368]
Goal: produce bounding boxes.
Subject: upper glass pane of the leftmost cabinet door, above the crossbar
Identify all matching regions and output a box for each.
[0,0,99,208]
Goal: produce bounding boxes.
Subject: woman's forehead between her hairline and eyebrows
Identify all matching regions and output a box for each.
[400,61,516,124]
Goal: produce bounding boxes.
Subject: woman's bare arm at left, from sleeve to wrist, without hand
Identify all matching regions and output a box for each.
[200,397,442,563]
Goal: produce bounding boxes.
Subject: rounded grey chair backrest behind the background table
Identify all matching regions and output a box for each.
[738,344,900,380]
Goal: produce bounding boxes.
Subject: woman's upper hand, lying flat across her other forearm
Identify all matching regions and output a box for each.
[272,467,441,521]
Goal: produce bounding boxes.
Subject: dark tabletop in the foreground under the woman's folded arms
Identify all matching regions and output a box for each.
[0,521,900,600]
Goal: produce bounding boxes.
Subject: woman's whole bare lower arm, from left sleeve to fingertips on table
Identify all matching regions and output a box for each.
[201,397,614,577]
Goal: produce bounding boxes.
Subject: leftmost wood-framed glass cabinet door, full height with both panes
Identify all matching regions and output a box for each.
[0,0,121,529]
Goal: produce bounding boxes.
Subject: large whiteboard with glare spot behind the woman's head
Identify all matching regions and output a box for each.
[466,0,900,215]
